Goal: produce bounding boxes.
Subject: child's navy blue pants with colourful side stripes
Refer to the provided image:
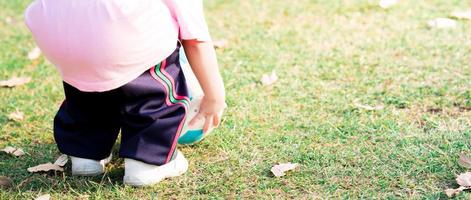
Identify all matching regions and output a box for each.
[54,47,189,165]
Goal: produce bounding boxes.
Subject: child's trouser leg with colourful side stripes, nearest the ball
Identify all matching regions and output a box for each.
[120,45,189,166]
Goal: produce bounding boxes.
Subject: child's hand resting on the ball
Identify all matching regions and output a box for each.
[189,96,227,133]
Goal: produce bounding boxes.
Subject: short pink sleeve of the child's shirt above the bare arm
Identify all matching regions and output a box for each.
[165,0,211,41]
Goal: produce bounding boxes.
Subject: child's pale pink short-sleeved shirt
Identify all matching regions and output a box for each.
[25,0,211,92]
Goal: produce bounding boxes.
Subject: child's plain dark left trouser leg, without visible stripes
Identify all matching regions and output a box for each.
[54,83,121,160]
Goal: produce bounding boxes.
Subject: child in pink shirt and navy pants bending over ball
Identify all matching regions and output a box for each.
[25,0,225,186]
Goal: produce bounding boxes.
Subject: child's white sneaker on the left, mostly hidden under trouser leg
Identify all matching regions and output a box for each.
[70,155,111,176]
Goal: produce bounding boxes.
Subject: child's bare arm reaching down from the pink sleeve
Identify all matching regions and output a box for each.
[182,40,226,132]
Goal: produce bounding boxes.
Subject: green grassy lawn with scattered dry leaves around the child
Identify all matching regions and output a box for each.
[0,0,471,199]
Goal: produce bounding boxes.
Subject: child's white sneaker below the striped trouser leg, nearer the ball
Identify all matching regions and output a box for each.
[123,151,188,187]
